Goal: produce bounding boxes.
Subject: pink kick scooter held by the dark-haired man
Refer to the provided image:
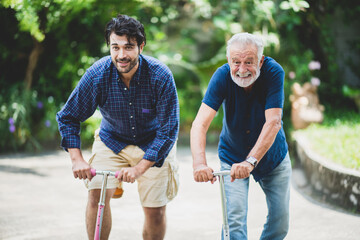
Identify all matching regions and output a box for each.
[91,169,119,240]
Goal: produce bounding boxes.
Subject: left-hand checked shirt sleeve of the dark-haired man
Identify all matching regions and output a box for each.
[56,70,98,151]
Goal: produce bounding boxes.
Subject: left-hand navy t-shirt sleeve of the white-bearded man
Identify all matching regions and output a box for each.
[202,66,229,111]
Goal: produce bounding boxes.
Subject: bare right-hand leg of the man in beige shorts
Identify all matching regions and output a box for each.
[143,205,166,240]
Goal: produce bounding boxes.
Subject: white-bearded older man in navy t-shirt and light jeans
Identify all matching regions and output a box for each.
[191,33,291,240]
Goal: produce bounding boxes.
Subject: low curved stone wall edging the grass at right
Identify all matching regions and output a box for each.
[294,133,360,213]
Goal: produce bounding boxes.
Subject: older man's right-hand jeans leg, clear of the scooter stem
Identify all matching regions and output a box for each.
[259,154,291,240]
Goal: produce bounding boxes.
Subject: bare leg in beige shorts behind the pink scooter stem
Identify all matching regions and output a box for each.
[86,189,115,240]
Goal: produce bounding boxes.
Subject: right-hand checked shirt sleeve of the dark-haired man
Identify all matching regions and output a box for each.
[143,73,180,167]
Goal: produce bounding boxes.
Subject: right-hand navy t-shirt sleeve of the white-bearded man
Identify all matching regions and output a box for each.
[264,60,285,110]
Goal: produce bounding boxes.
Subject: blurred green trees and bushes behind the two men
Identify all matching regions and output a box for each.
[0,0,360,152]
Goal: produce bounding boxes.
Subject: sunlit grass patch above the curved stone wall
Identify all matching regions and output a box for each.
[298,109,360,170]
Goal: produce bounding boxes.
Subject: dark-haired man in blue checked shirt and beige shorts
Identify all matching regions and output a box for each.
[57,15,179,239]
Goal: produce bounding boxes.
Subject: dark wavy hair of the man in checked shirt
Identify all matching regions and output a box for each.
[105,14,146,47]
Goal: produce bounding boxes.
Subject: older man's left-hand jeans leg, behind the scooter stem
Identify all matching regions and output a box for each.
[221,162,249,240]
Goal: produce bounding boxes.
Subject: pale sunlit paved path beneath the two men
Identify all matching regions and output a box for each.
[0,148,360,240]
